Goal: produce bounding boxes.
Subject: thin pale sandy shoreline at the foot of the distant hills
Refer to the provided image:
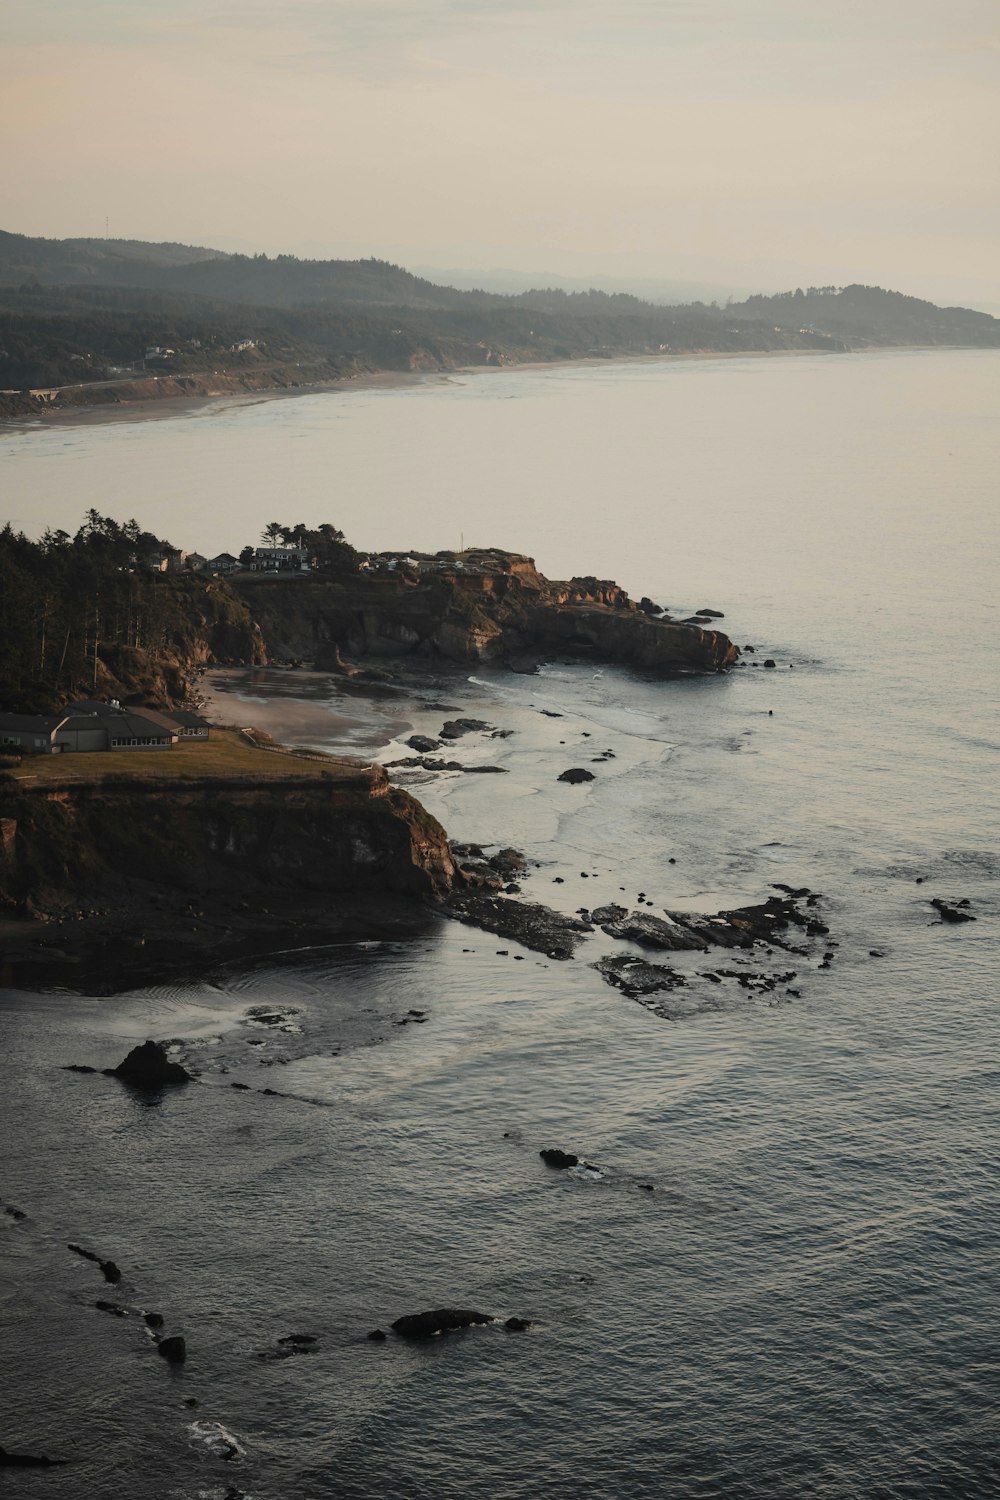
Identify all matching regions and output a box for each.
[0,344,971,435]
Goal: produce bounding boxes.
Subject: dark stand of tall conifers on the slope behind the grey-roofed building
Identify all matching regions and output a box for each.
[0,510,252,713]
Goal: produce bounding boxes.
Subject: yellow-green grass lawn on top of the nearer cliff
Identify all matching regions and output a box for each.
[4,729,372,788]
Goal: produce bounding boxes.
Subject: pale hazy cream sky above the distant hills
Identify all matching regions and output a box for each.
[0,0,1000,308]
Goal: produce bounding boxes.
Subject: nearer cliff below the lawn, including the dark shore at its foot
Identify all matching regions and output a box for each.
[0,752,454,989]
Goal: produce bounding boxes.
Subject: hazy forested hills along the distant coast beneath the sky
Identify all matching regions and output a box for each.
[0,233,1000,417]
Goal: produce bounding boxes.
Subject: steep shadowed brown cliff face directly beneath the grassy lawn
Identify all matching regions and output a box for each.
[0,767,454,911]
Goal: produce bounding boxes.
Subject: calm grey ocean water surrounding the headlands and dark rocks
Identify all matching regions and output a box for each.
[0,351,1000,1500]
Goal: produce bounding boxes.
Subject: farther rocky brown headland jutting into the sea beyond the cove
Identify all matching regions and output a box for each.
[234,549,738,675]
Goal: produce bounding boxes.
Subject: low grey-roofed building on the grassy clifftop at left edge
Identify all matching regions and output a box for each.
[0,699,210,755]
